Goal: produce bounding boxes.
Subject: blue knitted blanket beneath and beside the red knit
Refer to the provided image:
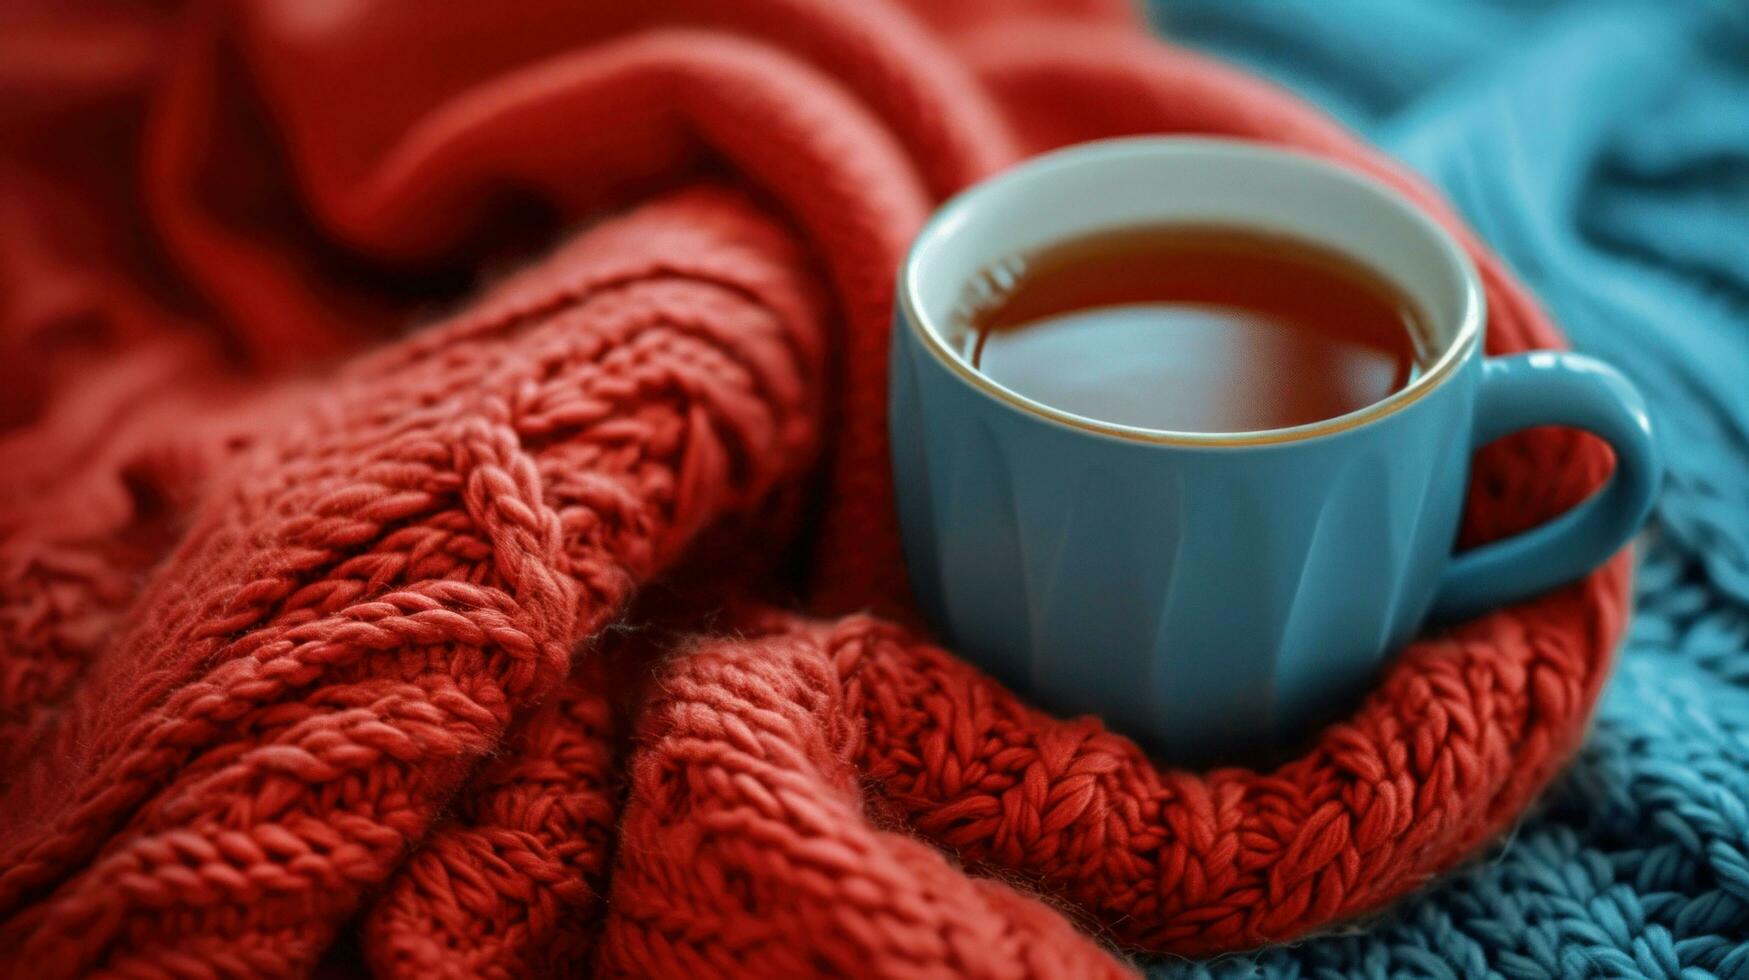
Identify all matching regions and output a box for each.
[1151,0,1749,980]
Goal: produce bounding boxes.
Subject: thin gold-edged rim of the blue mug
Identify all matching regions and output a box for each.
[899,137,1487,446]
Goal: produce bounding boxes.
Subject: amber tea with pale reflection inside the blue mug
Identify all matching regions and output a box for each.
[958,226,1427,432]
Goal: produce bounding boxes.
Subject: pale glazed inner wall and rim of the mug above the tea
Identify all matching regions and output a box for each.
[899,137,1483,445]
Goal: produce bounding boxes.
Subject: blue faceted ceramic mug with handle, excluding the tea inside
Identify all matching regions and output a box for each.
[888,138,1660,761]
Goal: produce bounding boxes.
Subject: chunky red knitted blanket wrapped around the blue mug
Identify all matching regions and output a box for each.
[0,0,1628,978]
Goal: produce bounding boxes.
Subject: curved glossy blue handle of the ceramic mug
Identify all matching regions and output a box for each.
[1432,350,1663,620]
